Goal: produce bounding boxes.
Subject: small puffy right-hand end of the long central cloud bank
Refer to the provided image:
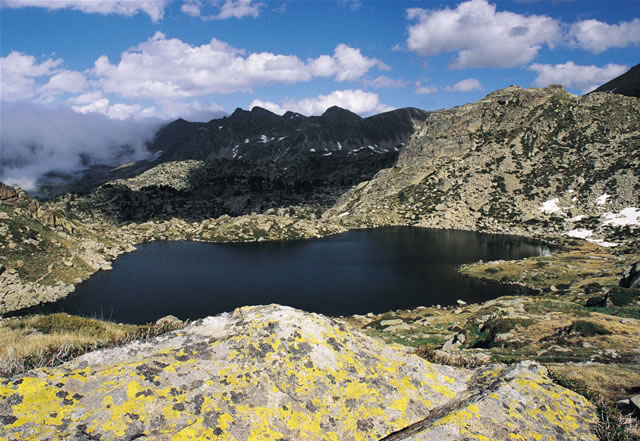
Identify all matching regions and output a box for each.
[308,44,390,81]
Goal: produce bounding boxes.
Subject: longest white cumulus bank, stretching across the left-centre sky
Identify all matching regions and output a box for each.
[92,32,388,99]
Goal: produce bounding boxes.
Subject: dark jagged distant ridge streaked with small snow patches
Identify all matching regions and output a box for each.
[149,106,429,163]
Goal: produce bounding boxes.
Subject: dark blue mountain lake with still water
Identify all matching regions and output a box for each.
[22,227,549,323]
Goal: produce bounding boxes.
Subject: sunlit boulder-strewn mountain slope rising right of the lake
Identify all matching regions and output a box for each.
[325,87,640,246]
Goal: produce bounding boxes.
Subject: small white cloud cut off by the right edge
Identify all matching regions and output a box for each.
[569,18,640,54]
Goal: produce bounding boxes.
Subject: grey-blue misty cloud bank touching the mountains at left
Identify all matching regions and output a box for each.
[0,102,160,190]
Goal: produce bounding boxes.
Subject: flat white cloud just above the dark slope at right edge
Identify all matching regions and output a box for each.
[529,61,628,93]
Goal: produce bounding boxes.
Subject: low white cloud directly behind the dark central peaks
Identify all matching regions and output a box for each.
[249,89,393,115]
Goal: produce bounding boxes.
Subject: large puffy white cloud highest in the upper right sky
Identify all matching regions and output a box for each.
[407,0,562,69]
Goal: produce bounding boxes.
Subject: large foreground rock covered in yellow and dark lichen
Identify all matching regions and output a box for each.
[0,305,597,441]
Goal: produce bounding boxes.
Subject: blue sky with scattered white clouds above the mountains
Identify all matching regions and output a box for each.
[0,0,640,120]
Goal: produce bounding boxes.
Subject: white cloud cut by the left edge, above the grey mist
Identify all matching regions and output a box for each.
[0,51,62,101]
